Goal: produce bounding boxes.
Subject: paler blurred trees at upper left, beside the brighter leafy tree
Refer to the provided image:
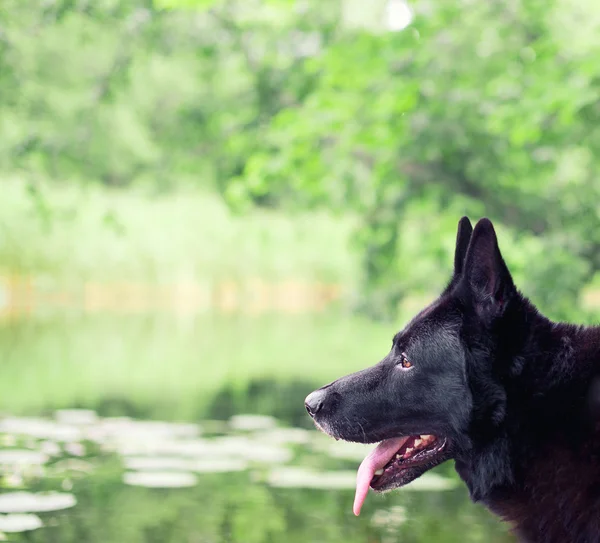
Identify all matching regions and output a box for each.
[0,0,334,190]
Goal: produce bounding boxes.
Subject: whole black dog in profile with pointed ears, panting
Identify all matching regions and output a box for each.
[306,217,600,543]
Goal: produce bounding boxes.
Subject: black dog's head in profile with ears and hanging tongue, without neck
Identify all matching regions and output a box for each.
[305,217,526,514]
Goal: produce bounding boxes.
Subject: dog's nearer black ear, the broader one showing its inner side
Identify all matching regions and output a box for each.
[463,219,515,318]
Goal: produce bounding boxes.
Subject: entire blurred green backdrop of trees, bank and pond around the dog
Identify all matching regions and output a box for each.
[0,0,600,543]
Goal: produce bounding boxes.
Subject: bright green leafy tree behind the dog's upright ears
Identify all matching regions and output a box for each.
[231,0,600,317]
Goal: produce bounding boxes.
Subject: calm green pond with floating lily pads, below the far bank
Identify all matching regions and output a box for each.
[0,315,512,543]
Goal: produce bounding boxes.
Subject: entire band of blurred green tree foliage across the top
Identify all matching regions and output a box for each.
[0,0,600,318]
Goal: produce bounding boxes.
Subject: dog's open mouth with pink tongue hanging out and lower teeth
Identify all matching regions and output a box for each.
[353,434,447,515]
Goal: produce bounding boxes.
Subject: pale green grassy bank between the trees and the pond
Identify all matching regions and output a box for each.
[0,179,356,284]
